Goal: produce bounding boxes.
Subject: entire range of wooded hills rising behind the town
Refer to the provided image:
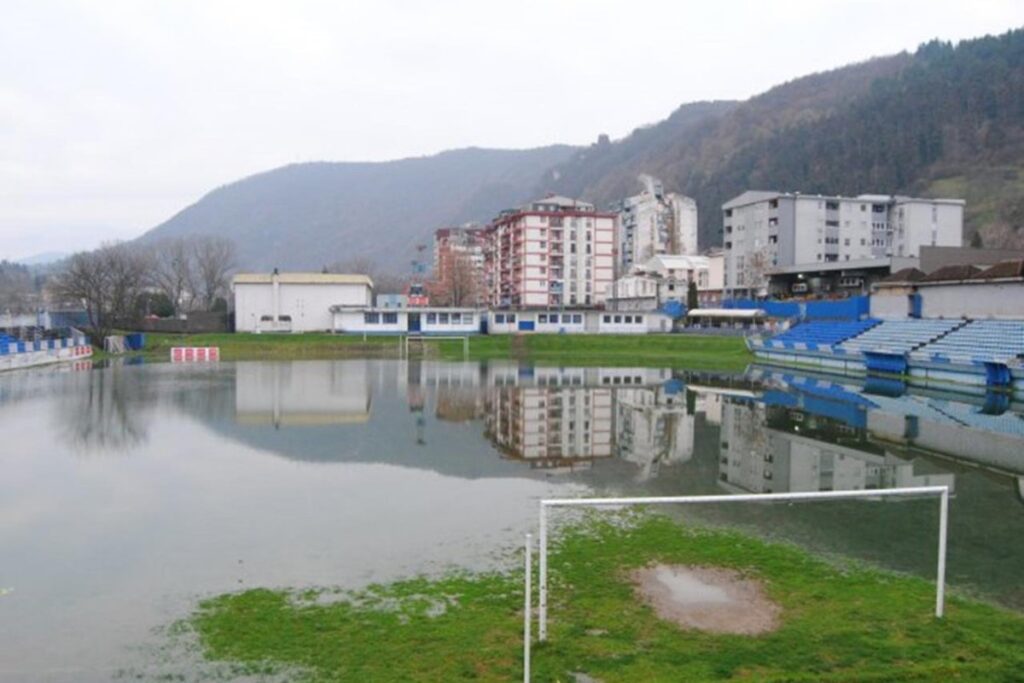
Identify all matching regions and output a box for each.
[143,30,1024,271]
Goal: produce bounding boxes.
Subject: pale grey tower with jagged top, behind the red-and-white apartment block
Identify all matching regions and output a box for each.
[614,175,697,274]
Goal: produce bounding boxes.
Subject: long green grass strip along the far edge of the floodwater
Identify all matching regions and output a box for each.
[128,334,752,371]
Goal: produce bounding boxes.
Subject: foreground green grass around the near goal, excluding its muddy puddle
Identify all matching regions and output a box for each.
[189,515,1024,681]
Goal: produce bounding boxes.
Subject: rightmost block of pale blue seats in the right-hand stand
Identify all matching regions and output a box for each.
[910,321,1024,362]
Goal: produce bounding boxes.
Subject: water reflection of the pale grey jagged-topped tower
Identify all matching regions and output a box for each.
[615,382,694,480]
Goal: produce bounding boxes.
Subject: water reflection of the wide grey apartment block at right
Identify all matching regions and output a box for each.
[719,397,954,493]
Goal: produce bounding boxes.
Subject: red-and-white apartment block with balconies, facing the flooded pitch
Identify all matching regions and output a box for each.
[485,197,615,308]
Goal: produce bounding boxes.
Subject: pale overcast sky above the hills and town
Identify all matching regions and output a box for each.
[0,0,1024,258]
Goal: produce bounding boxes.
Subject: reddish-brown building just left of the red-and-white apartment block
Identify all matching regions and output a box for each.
[431,224,487,306]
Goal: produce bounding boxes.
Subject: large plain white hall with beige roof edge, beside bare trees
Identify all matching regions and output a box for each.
[231,270,374,333]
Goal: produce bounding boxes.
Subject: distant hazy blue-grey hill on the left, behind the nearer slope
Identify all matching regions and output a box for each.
[141,145,574,273]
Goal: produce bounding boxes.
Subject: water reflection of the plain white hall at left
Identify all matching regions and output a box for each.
[234,360,372,427]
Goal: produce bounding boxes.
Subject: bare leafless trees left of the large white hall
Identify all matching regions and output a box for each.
[48,237,237,336]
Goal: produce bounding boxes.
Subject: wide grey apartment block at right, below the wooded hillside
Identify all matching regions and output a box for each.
[722,191,965,294]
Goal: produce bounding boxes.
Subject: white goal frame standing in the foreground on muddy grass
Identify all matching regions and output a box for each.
[536,486,949,661]
